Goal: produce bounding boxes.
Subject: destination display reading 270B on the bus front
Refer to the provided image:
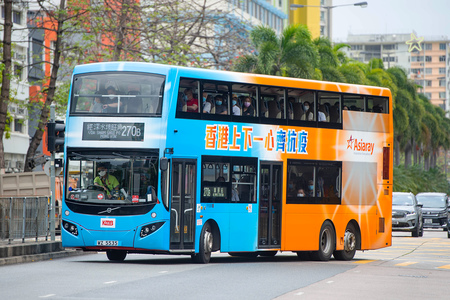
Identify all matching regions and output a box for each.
[83,122,144,142]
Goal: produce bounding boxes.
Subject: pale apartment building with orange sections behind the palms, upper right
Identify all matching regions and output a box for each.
[346,32,450,111]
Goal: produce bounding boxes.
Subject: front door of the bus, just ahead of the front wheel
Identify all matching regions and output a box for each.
[170,159,197,250]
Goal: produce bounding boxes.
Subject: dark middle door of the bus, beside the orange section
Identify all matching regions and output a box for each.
[258,162,283,248]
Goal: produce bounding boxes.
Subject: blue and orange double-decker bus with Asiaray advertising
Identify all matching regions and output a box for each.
[62,62,393,263]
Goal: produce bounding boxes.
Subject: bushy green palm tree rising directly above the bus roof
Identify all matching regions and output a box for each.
[233,24,318,79]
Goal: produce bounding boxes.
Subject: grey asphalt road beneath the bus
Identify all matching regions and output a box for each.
[0,230,450,300]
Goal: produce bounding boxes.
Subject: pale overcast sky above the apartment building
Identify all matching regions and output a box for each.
[332,0,450,42]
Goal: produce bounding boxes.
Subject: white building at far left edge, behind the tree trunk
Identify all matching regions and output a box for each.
[0,3,30,173]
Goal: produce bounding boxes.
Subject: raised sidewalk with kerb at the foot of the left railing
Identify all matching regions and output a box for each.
[0,236,83,266]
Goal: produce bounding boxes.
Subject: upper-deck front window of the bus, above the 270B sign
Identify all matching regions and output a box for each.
[70,72,165,116]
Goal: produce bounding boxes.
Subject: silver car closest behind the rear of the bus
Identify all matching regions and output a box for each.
[392,192,423,237]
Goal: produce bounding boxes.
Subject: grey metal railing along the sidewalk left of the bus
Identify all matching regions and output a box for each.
[0,196,61,243]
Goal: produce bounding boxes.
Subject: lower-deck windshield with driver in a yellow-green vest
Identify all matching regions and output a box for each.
[66,150,158,205]
